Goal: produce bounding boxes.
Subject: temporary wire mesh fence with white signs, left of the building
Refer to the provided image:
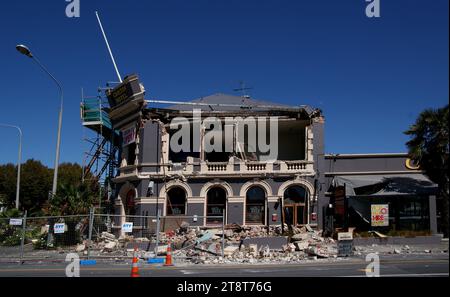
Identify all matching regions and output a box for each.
[0,209,225,262]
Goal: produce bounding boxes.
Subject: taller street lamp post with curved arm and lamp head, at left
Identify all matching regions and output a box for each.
[16,44,64,197]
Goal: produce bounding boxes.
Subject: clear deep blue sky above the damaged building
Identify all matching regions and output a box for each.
[0,0,449,166]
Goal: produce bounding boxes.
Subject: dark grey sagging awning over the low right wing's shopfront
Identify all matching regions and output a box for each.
[333,173,437,196]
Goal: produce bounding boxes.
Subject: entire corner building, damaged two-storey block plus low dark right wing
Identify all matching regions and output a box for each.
[82,75,439,233]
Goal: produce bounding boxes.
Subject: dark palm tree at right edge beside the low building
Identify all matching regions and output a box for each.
[404,105,449,237]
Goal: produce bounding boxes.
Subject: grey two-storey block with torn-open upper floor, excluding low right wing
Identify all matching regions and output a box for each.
[110,77,324,226]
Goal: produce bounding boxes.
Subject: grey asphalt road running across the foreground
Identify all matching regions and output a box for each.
[0,254,449,278]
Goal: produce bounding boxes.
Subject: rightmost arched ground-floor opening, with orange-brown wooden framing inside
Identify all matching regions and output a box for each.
[283,186,309,225]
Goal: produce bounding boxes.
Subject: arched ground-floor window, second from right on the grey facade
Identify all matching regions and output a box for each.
[245,186,266,224]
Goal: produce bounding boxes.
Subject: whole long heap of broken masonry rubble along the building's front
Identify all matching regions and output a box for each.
[76,222,337,264]
